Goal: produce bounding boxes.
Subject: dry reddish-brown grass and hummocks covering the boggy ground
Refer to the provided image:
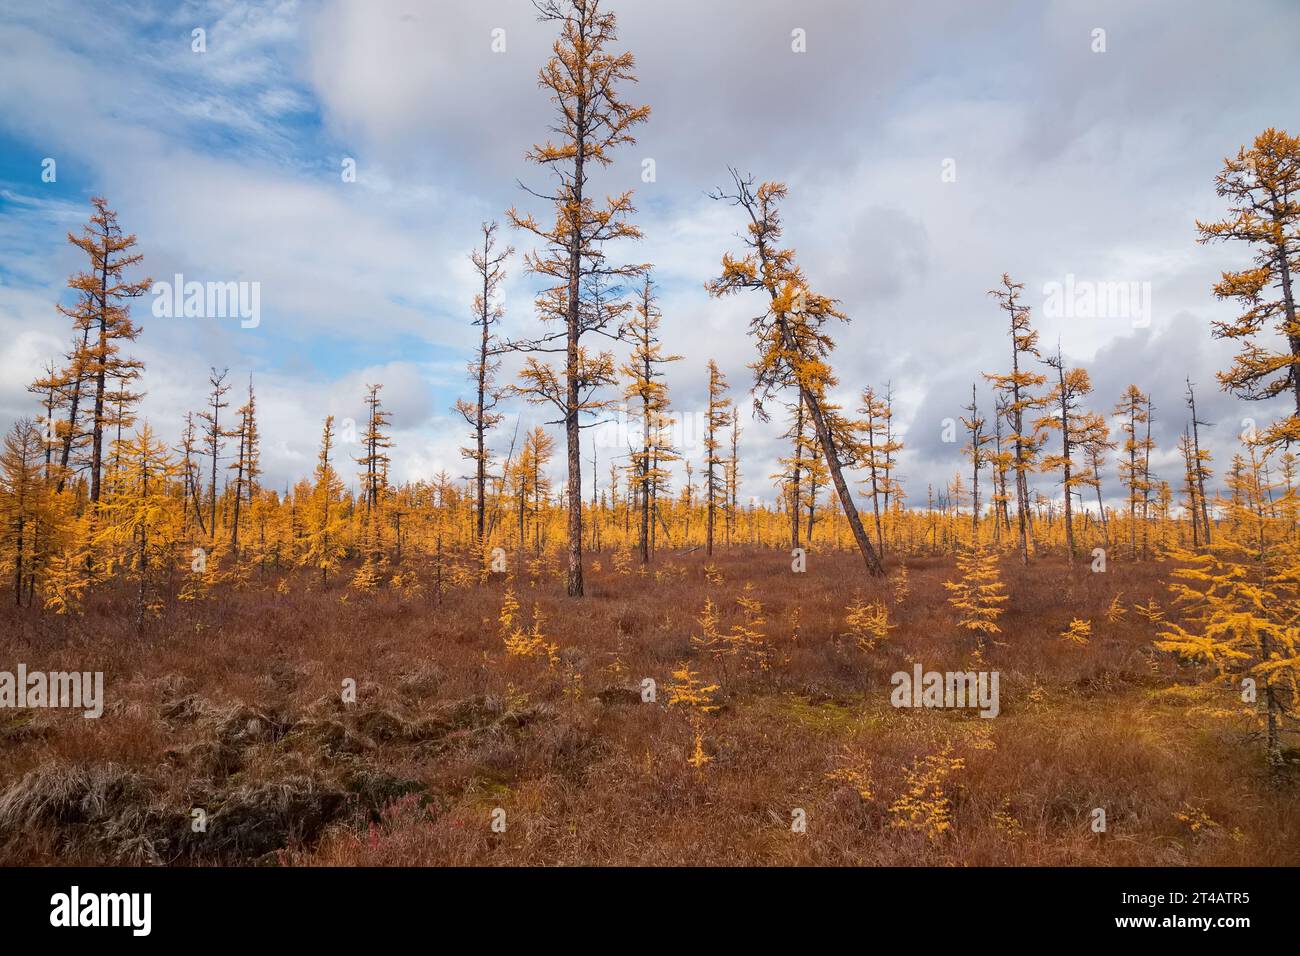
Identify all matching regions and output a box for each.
[0,550,1300,865]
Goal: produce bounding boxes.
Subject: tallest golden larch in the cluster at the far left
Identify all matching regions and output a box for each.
[59,196,152,502]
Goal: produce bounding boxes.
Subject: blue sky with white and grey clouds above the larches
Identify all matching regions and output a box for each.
[0,0,1300,505]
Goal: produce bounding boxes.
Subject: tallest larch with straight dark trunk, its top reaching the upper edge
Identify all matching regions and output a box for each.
[507,0,650,597]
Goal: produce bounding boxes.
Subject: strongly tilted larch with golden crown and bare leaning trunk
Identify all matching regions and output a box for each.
[709,169,884,575]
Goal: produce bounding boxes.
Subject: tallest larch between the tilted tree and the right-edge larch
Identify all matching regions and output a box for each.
[984,272,1047,564]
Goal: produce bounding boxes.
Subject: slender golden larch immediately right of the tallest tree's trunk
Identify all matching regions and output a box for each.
[620,272,681,564]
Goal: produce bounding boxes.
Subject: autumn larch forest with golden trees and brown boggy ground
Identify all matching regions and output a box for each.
[0,0,1300,866]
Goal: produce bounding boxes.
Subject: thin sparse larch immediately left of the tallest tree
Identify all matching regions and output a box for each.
[456,222,515,548]
